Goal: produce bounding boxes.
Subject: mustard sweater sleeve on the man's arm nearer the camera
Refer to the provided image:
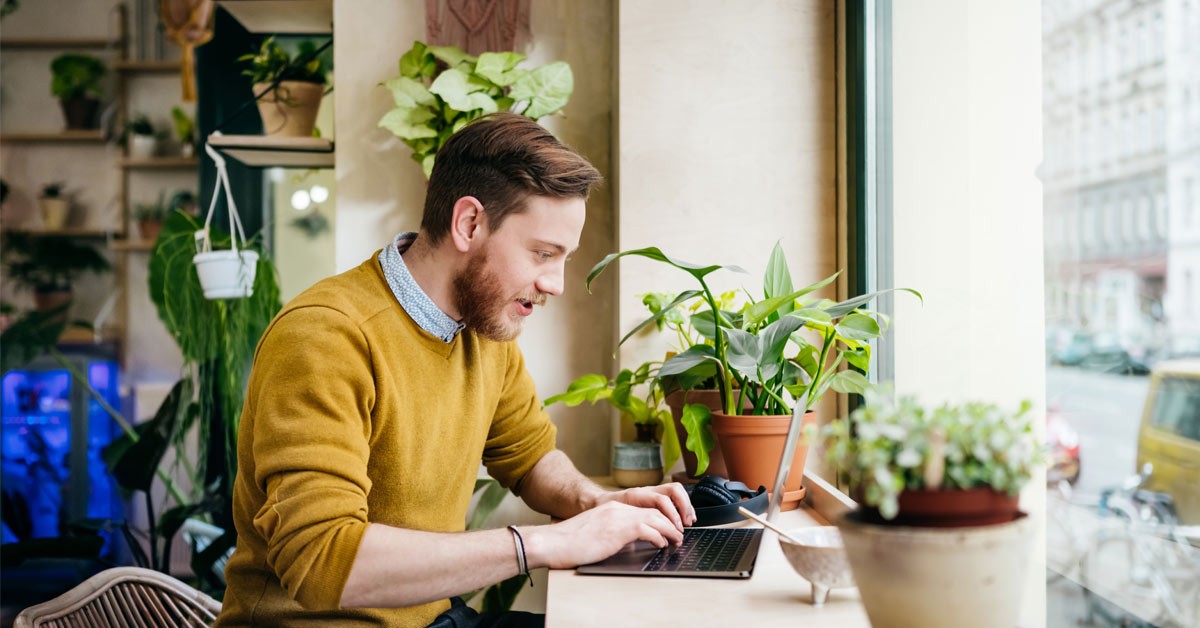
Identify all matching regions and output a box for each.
[247,306,374,610]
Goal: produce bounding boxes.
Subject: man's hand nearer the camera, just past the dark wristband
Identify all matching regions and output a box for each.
[520,501,695,569]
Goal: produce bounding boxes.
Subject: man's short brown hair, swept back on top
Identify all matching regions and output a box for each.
[421,113,601,244]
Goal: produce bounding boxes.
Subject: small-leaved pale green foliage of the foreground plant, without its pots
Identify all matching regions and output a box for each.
[821,387,1044,520]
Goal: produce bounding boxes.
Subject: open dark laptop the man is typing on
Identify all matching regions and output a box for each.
[576,406,804,579]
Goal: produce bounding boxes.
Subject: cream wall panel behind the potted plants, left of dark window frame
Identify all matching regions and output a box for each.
[607,0,840,449]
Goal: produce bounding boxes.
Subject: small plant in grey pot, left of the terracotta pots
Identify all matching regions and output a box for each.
[545,363,679,486]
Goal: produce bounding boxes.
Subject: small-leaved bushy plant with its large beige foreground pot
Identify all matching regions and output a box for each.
[822,387,1044,628]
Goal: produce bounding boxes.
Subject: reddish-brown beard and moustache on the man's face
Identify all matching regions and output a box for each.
[454,249,546,342]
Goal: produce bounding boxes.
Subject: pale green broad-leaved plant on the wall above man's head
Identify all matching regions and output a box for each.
[379,41,575,178]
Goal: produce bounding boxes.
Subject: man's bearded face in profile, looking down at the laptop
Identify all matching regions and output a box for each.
[454,196,586,341]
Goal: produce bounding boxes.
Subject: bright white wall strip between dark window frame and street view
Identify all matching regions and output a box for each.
[893,0,1045,626]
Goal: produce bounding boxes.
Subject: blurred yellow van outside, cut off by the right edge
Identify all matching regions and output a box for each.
[1138,359,1200,524]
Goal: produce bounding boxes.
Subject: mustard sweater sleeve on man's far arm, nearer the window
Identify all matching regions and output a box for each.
[484,342,557,495]
